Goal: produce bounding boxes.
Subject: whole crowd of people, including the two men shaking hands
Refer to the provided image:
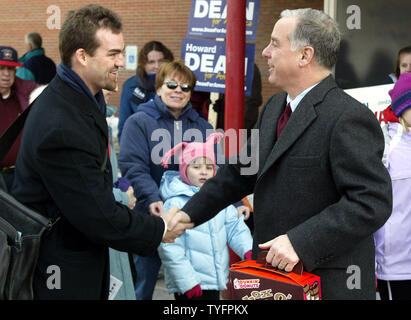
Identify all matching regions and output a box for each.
[0,5,411,300]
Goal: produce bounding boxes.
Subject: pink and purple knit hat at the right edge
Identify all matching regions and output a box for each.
[389,73,411,117]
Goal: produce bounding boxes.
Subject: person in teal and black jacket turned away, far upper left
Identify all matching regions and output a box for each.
[16,32,56,84]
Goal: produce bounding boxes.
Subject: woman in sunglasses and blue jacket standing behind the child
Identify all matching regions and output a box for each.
[118,60,213,300]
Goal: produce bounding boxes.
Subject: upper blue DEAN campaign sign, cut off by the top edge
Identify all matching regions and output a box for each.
[187,0,260,41]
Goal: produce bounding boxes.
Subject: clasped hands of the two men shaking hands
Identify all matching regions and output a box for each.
[161,207,194,243]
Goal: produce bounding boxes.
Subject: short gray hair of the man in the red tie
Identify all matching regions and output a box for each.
[280,8,341,70]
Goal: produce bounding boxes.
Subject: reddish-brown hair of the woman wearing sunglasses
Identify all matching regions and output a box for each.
[155,59,197,93]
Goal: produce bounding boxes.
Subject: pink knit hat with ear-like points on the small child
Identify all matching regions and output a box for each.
[161,132,224,184]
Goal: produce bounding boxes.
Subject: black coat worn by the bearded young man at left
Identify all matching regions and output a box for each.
[13,76,164,299]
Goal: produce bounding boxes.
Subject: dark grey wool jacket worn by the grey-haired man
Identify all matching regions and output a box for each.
[183,76,392,299]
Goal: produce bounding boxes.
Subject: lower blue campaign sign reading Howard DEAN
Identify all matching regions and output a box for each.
[181,38,255,96]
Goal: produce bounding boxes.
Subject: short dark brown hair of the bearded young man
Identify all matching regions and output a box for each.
[59,4,122,67]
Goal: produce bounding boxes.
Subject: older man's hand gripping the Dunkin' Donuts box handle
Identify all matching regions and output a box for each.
[258,234,300,272]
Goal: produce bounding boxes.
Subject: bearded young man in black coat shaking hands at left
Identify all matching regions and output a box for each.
[12,5,192,299]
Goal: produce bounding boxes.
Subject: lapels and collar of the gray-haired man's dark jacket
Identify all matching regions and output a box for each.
[259,75,337,177]
